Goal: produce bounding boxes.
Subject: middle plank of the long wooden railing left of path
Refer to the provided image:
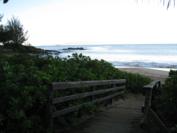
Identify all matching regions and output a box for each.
[52,86,125,104]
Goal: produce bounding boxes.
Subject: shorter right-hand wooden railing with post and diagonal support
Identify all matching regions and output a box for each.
[141,81,170,133]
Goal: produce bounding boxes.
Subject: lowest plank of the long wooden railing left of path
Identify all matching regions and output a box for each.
[52,91,124,118]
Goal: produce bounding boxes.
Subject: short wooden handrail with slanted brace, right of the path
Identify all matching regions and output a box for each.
[141,81,170,133]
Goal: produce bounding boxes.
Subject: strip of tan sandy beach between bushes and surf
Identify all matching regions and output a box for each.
[119,68,169,81]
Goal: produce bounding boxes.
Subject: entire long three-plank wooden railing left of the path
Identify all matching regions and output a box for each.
[49,79,126,132]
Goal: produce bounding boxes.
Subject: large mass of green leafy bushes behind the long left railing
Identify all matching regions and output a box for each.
[0,54,150,133]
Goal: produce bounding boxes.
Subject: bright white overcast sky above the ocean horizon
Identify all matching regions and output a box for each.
[0,0,177,45]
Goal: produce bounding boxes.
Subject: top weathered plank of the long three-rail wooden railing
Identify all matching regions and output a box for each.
[52,79,126,90]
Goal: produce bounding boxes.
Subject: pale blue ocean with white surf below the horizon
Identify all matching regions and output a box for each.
[39,44,177,71]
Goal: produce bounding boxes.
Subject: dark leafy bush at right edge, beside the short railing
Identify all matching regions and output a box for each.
[154,71,177,133]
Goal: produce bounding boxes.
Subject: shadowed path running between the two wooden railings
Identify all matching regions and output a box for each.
[67,95,144,133]
